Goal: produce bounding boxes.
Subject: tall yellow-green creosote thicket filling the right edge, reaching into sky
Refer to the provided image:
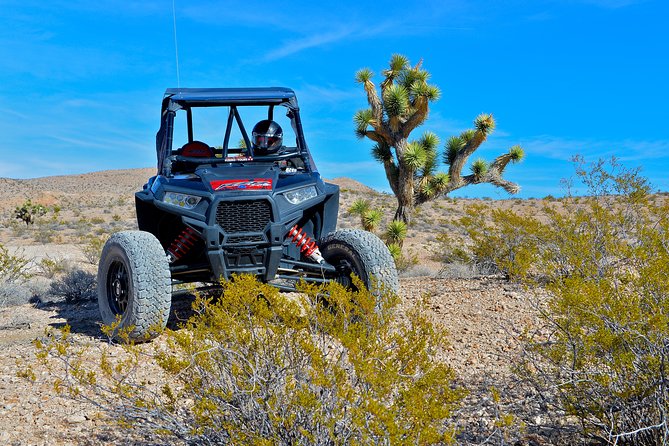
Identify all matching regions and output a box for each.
[454,158,669,445]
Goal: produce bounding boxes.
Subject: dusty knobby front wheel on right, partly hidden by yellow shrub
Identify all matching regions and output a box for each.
[319,229,399,293]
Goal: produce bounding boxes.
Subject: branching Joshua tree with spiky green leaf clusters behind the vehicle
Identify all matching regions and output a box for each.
[354,54,524,222]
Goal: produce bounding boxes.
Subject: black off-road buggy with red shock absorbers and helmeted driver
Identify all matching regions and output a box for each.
[98,88,398,340]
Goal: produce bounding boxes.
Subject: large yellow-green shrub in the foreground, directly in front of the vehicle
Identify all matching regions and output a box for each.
[34,276,463,445]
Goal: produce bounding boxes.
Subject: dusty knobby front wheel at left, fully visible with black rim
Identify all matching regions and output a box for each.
[98,231,172,341]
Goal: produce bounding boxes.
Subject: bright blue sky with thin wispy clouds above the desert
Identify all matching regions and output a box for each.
[0,0,669,198]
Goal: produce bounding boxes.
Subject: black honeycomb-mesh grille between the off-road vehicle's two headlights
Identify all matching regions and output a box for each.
[216,200,272,234]
